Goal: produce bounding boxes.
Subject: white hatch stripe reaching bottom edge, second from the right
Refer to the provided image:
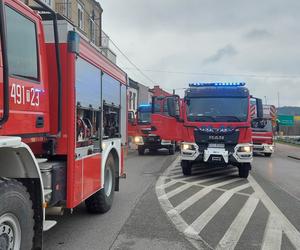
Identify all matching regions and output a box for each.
[216,196,259,250]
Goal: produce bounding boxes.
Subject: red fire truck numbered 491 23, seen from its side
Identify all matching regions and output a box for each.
[0,0,127,250]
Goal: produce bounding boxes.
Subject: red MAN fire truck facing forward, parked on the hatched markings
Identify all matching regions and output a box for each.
[152,83,252,178]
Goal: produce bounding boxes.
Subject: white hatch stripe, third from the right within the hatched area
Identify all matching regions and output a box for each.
[184,183,250,236]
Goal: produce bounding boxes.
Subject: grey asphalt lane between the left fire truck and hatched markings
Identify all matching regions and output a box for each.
[44,151,193,250]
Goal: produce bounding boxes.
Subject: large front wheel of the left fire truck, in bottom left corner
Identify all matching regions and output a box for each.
[0,179,34,250]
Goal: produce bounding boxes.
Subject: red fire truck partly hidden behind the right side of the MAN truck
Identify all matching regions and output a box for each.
[251,102,276,157]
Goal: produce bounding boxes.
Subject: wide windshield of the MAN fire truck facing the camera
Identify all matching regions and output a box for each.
[187,97,249,122]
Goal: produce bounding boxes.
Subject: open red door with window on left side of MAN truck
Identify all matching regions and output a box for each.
[151,95,183,141]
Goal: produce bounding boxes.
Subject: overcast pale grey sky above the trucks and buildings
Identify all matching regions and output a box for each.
[99,0,300,106]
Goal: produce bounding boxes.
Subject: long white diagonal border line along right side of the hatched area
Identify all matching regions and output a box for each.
[248,176,300,249]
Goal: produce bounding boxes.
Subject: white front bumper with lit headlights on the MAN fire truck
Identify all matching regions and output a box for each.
[181,142,253,164]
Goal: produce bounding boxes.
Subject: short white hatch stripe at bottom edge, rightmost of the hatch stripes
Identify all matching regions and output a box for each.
[261,214,282,250]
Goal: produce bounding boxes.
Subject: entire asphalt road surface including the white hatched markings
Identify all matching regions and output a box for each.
[44,144,300,250]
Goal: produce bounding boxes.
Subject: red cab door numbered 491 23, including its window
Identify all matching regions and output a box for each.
[0,0,49,135]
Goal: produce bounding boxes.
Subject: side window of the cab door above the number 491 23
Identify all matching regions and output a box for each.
[5,6,39,80]
